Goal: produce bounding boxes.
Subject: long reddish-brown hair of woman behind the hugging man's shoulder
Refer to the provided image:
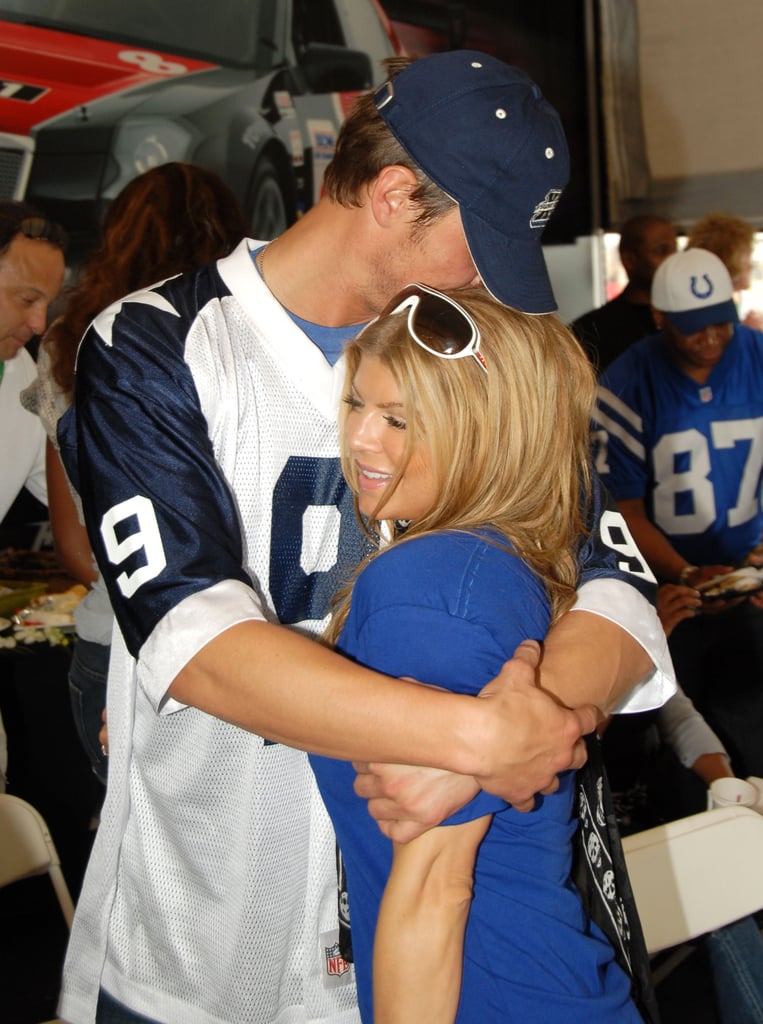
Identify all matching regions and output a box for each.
[43,162,248,395]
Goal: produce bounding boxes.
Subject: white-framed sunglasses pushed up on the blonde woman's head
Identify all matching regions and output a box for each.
[366,285,488,373]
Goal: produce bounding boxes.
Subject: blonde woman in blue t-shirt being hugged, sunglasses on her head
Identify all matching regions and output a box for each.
[310,285,641,1024]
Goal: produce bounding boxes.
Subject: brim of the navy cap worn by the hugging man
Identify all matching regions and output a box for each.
[460,207,557,313]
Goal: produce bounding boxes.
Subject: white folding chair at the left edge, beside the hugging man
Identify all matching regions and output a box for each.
[0,793,74,1024]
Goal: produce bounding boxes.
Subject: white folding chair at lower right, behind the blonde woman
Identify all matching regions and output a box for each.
[623,807,763,983]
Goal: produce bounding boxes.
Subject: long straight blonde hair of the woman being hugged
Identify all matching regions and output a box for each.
[327,289,595,641]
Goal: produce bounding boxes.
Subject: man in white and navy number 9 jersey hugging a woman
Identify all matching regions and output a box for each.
[57,51,672,1024]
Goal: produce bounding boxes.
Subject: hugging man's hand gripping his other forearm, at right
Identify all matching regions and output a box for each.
[477,640,601,811]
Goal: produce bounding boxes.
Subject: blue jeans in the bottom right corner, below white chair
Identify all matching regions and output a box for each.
[705,918,763,1024]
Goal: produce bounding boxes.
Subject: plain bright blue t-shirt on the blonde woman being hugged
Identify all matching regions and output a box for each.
[310,532,640,1024]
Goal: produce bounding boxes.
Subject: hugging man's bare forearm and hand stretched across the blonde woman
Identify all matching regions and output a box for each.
[169,622,596,806]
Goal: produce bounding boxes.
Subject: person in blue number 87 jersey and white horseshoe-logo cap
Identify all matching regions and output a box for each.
[594,249,763,776]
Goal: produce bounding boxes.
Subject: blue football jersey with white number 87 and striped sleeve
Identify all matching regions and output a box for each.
[594,326,763,565]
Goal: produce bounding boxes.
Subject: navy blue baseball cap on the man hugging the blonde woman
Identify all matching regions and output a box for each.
[375,50,569,313]
